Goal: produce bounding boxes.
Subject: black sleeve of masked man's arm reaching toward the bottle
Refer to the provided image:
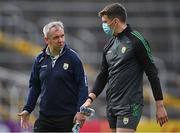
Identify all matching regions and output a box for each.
[91,52,108,97]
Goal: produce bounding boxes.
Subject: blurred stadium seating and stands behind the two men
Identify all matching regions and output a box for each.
[0,0,180,132]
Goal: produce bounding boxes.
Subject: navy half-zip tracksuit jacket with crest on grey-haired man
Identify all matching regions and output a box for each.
[23,45,88,116]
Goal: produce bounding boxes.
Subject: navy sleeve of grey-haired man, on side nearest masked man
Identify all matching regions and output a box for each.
[75,58,88,112]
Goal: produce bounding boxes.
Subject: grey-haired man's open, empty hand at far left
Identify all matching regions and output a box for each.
[18,110,30,129]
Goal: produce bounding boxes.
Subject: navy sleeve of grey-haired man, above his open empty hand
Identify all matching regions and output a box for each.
[23,59,41,113]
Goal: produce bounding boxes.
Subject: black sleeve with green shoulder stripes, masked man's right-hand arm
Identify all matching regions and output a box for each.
[135,33,163,100]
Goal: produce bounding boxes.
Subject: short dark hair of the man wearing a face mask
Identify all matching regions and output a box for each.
[98,3,127,22]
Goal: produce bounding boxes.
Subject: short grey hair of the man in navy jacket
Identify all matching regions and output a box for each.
[43,21,64,37]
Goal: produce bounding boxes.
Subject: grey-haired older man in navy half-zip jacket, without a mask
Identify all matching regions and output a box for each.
[18,21,88,132]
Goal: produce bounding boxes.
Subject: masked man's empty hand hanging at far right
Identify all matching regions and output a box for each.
[156,100,168,126]
